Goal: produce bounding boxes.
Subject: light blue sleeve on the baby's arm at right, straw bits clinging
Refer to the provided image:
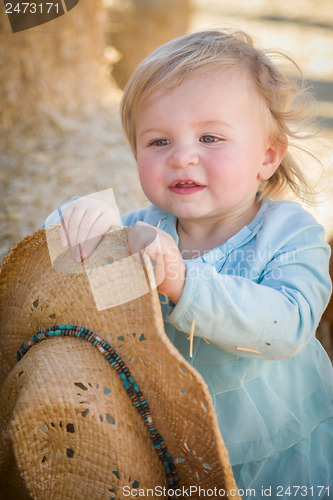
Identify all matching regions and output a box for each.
[167,215,331,359]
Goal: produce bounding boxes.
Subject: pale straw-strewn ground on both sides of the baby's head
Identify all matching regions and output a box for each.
[0,0,333,257]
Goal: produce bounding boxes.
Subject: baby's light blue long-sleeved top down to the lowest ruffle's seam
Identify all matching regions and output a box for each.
[122,199,333,465]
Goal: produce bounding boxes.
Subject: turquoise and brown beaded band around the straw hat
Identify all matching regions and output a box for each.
[16,325,179,500]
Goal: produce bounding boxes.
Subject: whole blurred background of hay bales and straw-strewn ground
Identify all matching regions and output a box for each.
[0,0,333,352]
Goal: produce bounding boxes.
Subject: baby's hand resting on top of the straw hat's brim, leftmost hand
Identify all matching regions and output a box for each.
[60,198,120,262]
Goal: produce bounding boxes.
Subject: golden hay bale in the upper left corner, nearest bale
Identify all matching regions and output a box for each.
[0,0,111,130]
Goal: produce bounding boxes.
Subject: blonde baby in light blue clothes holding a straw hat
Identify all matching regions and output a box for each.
[52,31,333,498]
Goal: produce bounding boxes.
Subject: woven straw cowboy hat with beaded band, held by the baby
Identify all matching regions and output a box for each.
[0,225,240,500]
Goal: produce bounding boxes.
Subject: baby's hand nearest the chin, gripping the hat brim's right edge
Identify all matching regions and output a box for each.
[128,222,186,304]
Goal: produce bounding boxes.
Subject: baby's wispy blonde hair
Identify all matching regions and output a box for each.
[121,31,312,201]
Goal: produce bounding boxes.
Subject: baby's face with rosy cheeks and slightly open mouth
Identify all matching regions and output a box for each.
[136,71,273,226]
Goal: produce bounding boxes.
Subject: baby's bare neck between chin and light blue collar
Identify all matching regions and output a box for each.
[177,203,260,259]
